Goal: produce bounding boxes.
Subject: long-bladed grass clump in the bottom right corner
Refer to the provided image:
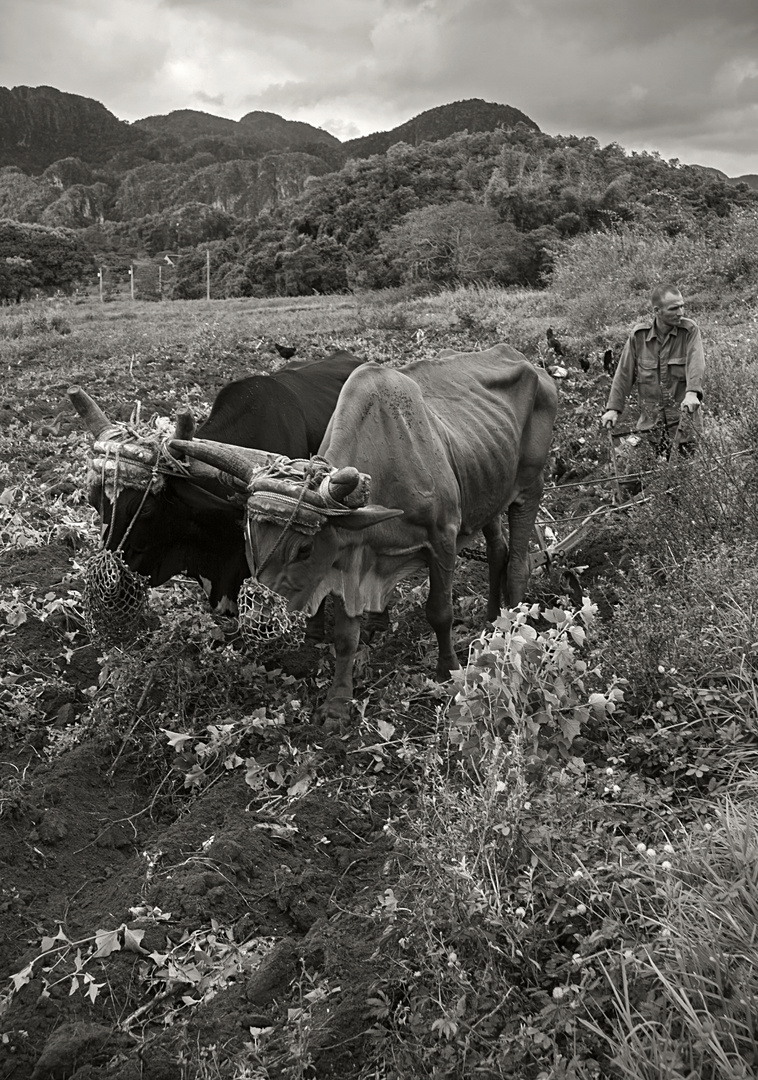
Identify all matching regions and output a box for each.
[587,786,758,1080]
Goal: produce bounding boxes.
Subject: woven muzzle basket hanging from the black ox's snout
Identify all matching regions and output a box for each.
[82,549,149,648]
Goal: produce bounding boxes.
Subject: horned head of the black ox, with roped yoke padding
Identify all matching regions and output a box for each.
[69,387,247,611]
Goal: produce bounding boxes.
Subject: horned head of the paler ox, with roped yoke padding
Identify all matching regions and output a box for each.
[172,438,403,615]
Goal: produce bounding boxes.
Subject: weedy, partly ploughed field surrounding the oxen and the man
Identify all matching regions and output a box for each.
[0,280,758,1080]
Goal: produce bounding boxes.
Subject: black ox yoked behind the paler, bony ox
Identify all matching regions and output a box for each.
[69,352,363,613]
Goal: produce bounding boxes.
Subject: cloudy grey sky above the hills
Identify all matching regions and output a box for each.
[0,0,758,176]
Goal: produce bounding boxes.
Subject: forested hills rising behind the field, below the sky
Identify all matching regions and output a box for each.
[0,86,758,299]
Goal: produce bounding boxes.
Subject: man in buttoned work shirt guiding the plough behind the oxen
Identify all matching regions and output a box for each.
[600,285,705,457]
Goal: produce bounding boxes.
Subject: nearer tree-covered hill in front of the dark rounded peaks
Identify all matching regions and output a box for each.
[198,127,754,298]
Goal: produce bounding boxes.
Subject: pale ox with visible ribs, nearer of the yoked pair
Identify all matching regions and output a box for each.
[173,345,557,720]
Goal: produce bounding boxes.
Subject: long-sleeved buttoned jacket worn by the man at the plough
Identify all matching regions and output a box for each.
[606,315,705,431]
